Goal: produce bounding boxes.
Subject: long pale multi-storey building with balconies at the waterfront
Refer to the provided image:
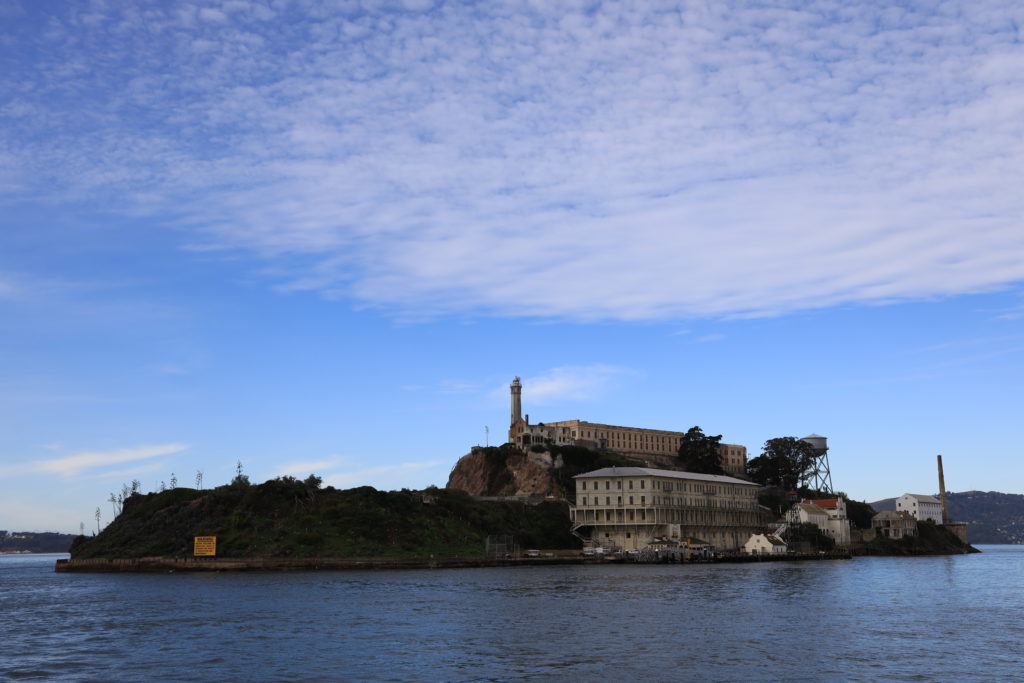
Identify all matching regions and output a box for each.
[569,467,772,552]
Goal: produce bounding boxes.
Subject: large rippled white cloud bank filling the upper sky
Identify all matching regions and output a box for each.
[6,0,1024,321]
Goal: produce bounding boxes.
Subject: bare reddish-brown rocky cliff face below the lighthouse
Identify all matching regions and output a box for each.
[447,447,565,498]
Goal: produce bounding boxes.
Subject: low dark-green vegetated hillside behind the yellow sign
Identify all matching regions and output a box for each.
[71,477,580,559]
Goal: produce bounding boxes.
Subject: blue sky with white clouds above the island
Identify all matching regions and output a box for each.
[0,0,1024,532]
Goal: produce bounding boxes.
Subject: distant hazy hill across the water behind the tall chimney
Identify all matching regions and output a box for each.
[871,490,1024,545]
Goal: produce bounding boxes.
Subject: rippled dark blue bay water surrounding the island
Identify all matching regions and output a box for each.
[0,546,1024,681]
